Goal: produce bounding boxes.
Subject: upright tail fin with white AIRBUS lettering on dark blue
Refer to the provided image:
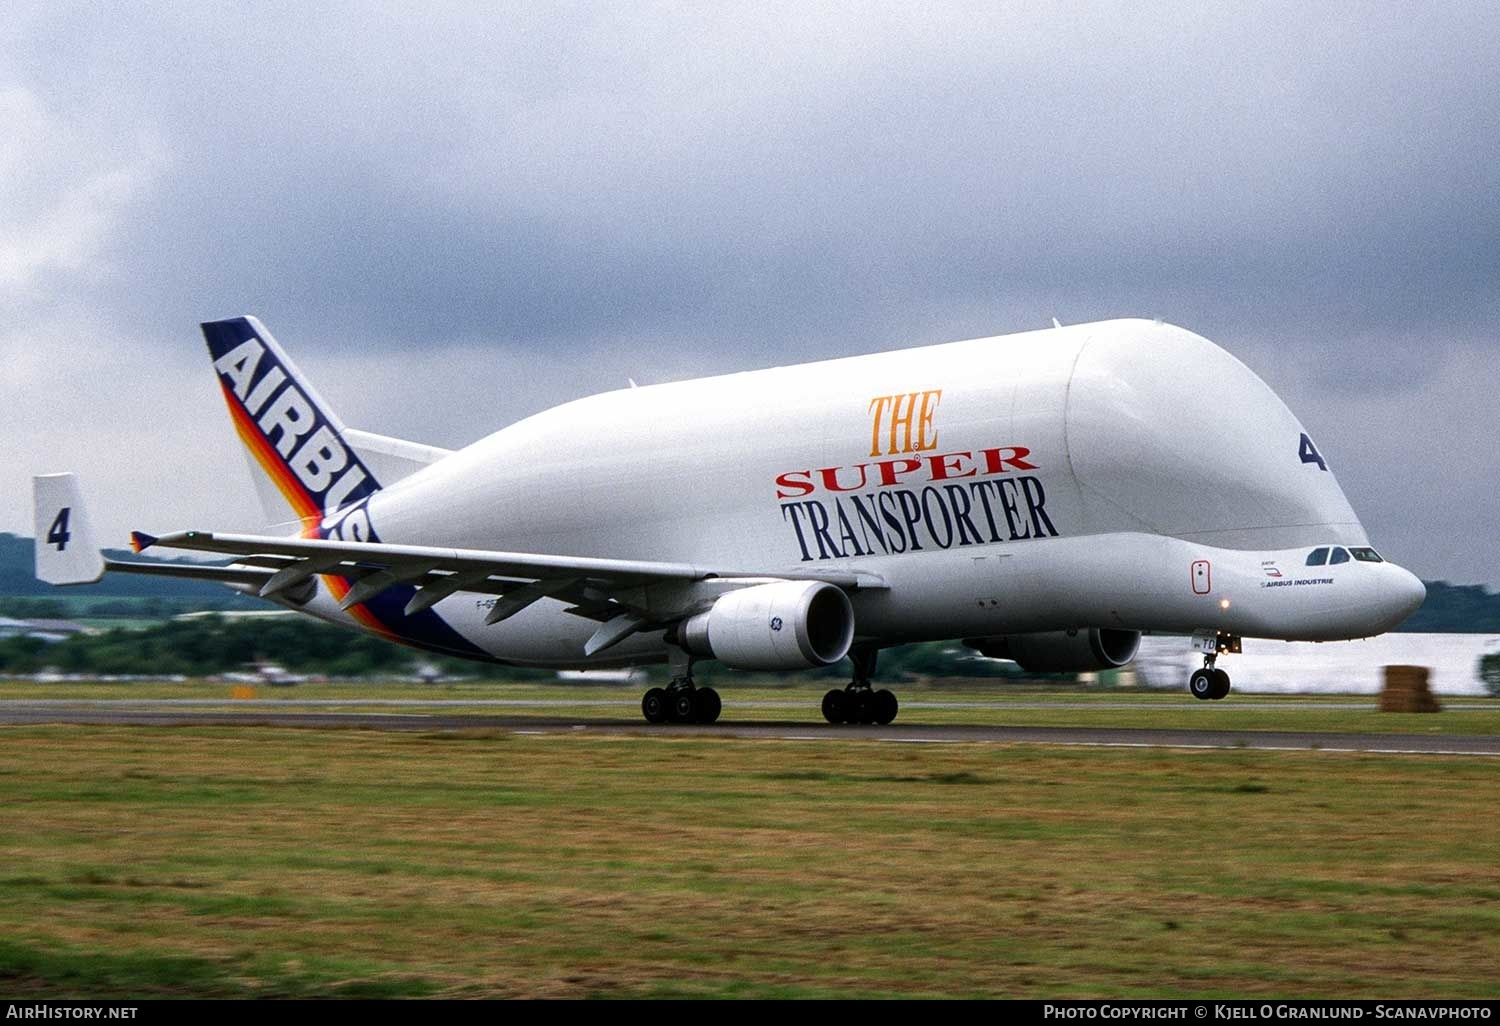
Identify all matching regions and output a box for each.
[203,317,380,525]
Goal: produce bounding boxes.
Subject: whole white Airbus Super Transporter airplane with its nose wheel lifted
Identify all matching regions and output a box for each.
[35,317,1425,725]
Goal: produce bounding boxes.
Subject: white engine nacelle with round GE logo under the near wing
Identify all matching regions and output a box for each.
[678,581,854,671]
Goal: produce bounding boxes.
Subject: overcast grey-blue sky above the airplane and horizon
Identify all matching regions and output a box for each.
[0,2,1500,587]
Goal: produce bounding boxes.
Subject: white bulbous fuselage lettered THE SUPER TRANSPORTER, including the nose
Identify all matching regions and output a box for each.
[334,320,1422,665]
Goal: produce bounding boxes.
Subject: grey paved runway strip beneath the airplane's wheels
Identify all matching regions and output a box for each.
[0,699,1500,756]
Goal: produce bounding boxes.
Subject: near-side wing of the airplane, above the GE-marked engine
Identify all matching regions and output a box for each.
[132,531,887,654]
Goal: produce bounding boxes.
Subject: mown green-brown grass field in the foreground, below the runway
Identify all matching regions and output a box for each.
[0,714,1500,998]
